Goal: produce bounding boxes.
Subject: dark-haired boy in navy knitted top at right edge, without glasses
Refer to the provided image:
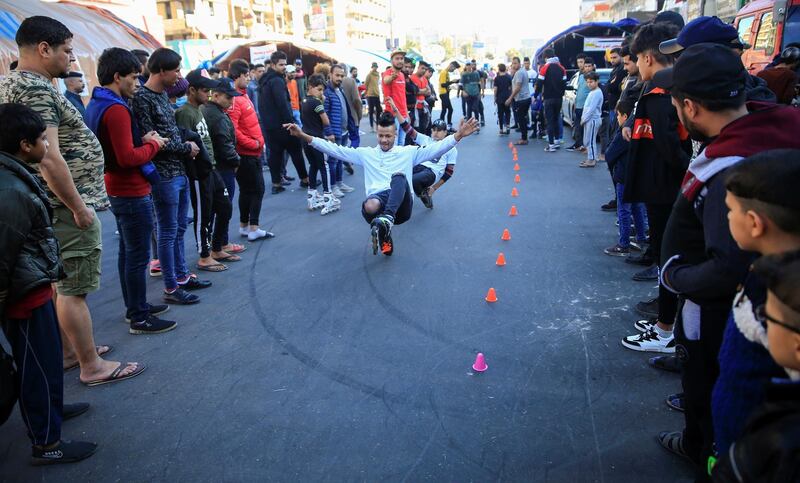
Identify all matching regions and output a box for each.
[712,149,800,472]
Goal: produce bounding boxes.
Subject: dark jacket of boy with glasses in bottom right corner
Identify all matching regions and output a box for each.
[712,379,800,483]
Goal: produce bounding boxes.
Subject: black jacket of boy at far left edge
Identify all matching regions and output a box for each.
[0,153,65,319]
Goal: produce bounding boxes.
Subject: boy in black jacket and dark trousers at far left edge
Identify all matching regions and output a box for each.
[0,104,97,465]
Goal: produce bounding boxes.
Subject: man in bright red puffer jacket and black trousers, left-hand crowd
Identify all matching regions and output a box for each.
[228,59,274,241]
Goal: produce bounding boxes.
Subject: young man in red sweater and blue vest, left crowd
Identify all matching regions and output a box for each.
[86,48,177,336]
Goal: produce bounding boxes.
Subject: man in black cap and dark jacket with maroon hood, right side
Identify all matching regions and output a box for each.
[653,43,800,480]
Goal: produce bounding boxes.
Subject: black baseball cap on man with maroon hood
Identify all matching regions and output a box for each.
[653,43,747,101]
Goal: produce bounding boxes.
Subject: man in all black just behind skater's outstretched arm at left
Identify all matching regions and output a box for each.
[258,51,306,194]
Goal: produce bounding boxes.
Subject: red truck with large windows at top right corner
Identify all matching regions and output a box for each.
[733,0,800,75]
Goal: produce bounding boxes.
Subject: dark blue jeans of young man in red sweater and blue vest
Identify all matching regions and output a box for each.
[108,195,154,322]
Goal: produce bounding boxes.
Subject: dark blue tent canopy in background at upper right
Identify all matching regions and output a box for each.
[534,18,639,69]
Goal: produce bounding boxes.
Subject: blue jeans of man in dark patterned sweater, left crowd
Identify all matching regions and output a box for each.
[153,175,189,290]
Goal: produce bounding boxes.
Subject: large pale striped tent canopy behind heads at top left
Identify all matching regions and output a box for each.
[0,0,161,86]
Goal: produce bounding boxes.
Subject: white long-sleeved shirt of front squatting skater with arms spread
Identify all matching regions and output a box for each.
[311,135,457,196]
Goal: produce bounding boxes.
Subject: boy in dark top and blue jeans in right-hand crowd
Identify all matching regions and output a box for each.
[604,98,647,257]
